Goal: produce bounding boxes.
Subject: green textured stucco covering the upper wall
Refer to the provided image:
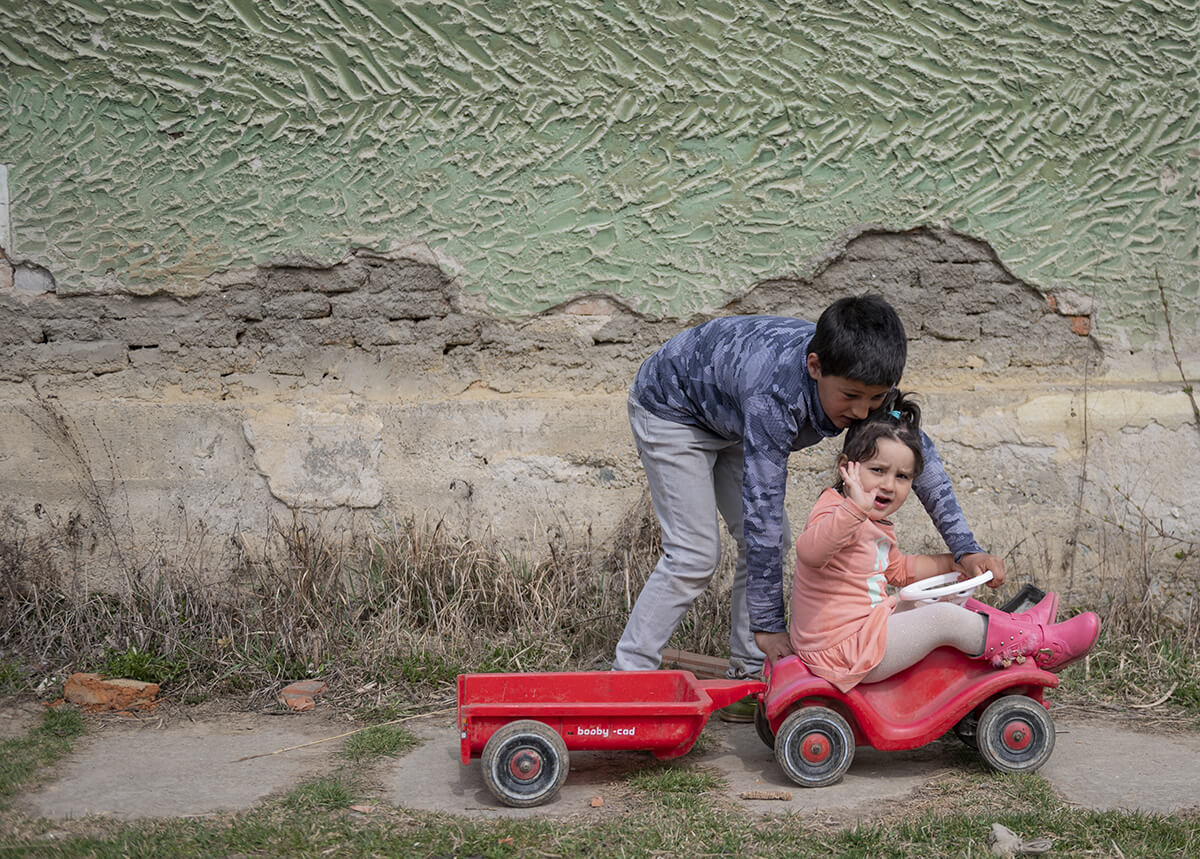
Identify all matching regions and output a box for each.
[0,0,1200,331]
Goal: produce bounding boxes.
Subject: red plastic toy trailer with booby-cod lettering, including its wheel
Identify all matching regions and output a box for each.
[458,671,767,807]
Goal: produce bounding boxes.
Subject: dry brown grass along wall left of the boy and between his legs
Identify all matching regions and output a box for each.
[0,499,728,707]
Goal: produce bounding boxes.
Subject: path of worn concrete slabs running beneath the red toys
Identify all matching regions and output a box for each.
[9,705,1200,819]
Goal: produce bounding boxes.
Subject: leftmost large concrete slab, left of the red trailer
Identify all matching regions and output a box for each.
[23,714,340,819]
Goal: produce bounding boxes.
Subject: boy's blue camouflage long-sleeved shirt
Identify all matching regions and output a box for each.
[631,317,983,632]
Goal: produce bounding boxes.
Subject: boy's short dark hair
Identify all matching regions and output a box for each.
[809,294,908,385]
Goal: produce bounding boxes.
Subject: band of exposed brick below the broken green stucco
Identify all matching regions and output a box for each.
[0,229,1097,398]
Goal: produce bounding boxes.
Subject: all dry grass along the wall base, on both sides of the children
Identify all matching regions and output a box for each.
[0,477,1200,721]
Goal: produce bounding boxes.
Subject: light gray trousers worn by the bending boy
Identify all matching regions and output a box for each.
[612,398,791,677]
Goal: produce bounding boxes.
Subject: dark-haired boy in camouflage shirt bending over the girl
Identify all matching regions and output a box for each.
[613,295,1004,720]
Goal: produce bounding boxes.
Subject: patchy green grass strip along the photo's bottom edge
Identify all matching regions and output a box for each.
[0,767,1200,859]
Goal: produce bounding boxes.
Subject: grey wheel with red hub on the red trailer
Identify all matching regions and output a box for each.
[480,719,570,809]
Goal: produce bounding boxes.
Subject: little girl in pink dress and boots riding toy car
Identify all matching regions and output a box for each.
[788,391,1099,692]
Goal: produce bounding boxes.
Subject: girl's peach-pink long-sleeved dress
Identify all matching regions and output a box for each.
[788,488,913,692]
